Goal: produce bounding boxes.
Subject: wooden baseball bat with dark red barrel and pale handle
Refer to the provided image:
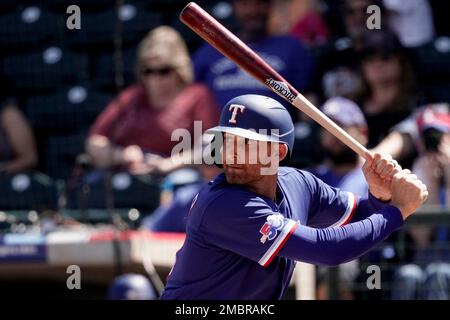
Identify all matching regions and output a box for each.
[180,2,369,159]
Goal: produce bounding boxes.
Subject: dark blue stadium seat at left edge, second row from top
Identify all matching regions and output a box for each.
[2,46,88,94]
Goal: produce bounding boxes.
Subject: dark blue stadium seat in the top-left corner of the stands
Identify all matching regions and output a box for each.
[0,5,62,52]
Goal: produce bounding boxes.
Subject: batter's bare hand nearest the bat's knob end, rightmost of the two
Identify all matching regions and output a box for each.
[391,169,428,220]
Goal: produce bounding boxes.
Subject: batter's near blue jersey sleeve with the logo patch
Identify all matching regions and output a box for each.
[200,191,299,267]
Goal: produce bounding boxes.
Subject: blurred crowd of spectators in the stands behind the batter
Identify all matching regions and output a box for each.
[0,0,450,299]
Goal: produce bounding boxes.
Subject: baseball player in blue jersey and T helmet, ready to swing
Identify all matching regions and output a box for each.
[161,95,428,300]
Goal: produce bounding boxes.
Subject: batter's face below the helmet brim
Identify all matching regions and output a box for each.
[222,133,279,185]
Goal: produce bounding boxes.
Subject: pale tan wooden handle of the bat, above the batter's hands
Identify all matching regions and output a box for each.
[292,94,371,159]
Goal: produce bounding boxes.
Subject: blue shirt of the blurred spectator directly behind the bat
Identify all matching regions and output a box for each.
[193,36,313,110]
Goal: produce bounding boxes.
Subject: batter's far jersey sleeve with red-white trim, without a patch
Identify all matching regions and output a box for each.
[301,171,358,228]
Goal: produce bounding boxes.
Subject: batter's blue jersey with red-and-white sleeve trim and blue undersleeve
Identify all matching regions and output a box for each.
[161,167,403,300]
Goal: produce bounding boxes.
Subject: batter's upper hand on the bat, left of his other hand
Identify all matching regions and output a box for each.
[362,153,402,201]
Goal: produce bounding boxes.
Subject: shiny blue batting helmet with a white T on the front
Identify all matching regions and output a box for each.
[206,94,295,165]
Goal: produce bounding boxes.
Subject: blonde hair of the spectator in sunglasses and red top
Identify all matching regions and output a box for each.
[136,26,194,84]
